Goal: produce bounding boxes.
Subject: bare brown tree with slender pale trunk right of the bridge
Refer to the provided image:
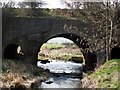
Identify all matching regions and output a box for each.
[62,0,120,60]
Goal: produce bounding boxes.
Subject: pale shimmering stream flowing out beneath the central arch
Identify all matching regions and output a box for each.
[37,60,82,88]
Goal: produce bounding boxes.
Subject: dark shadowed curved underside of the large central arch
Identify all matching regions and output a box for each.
[36,33,97,70]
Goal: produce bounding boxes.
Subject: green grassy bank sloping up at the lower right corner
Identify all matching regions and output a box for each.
[82,59,120,88]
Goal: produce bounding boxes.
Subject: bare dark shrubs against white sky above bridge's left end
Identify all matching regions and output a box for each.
[0,0,47,17]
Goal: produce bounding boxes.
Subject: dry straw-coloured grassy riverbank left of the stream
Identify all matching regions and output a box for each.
[0,60,48,89]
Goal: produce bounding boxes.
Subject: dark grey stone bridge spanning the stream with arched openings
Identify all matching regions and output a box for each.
[2,17,120,69]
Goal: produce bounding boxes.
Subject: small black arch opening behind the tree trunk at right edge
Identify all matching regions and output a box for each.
[111,47,120,59]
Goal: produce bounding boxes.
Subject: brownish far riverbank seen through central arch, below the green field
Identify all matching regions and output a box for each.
[38,47,84,62]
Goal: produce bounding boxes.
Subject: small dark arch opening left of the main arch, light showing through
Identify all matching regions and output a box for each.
[4,44,25,60]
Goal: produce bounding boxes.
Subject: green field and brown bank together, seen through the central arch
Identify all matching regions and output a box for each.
[38,43,83,61]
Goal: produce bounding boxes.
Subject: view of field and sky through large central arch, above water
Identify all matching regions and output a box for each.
[38,34,85,64]
